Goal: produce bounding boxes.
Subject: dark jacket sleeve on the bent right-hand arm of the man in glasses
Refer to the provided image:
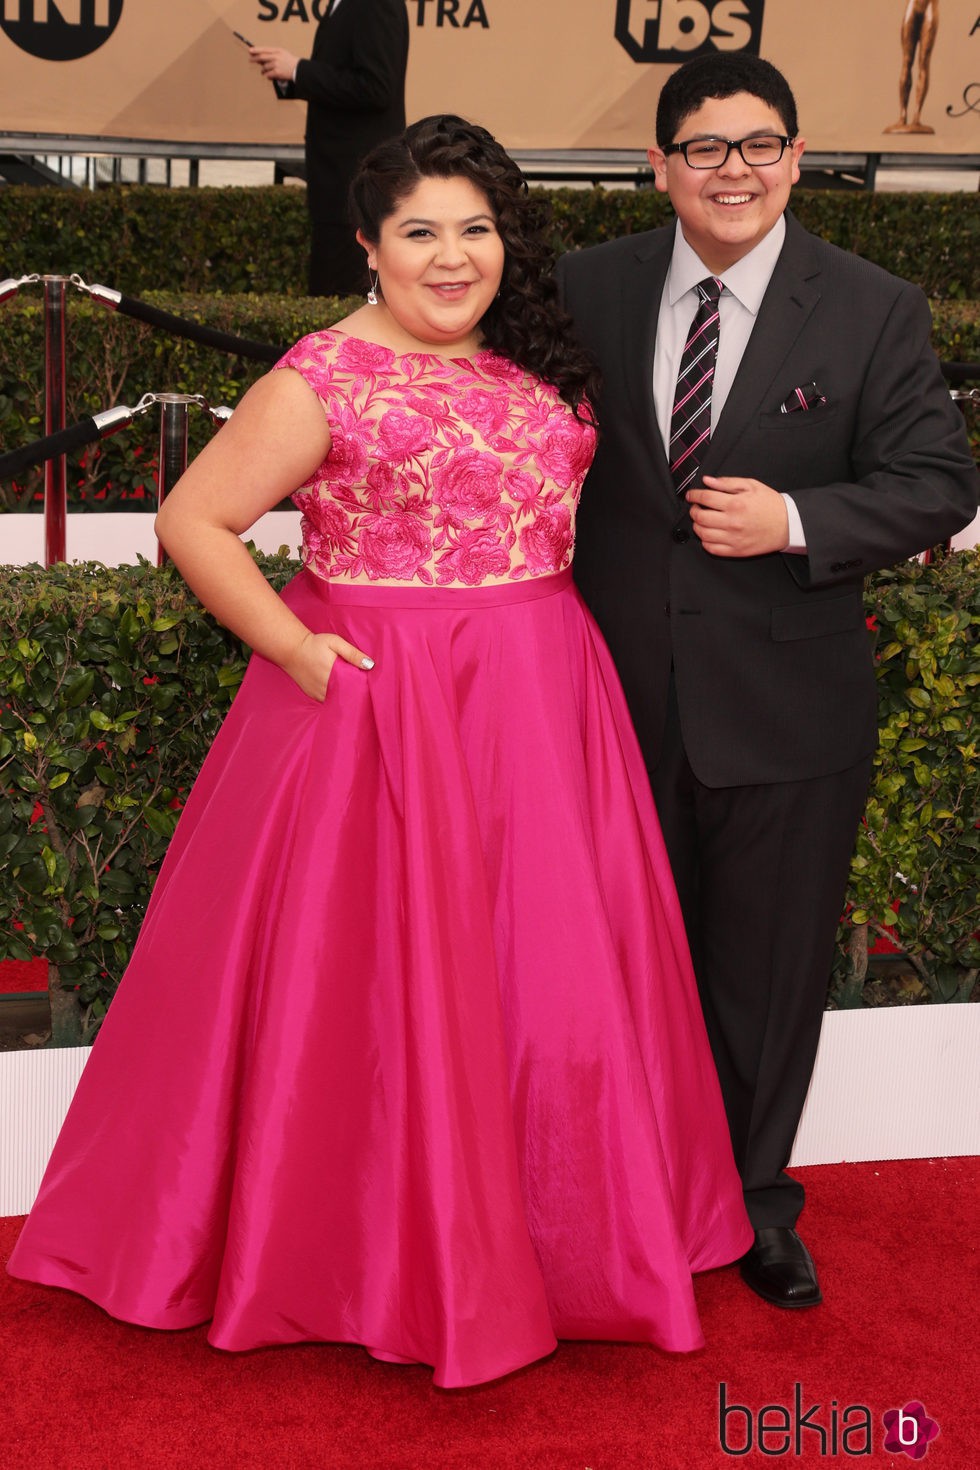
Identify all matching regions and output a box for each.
[777,282,980,587]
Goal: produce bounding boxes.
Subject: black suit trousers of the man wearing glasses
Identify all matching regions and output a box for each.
[649,676,871,1230]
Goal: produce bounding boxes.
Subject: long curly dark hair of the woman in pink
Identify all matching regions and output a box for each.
[350,113,598,419]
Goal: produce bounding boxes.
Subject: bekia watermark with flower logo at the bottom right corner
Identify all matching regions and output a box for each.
[718,1383,939,1460]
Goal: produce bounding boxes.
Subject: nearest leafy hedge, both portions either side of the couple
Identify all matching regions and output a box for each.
[0,551,980,1041]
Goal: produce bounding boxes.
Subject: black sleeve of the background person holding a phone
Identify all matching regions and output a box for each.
[291,0,407,112]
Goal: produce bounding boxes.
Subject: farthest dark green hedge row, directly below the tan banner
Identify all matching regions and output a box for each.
[0,185,980,300]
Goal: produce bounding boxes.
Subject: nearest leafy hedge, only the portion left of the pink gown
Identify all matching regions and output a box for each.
[0,556,295,1041]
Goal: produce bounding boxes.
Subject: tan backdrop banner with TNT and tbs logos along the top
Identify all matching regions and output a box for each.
[0,0,980,153]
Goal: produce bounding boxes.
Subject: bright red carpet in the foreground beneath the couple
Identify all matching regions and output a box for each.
[0,1158,980,1470]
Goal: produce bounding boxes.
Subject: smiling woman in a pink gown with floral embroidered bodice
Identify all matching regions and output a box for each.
[10,118,752,1388]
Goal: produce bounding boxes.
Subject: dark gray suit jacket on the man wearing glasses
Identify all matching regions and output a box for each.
[558,215,979,786]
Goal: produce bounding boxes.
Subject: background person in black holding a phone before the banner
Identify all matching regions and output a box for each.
[248,0,408,295]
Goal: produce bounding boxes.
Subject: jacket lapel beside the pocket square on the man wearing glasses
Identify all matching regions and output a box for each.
[702,215,820,475]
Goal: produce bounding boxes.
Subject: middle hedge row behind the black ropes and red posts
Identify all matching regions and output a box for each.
[0,289,980,510]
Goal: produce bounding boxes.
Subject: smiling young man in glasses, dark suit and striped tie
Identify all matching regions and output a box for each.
[558,53,977,1307]
